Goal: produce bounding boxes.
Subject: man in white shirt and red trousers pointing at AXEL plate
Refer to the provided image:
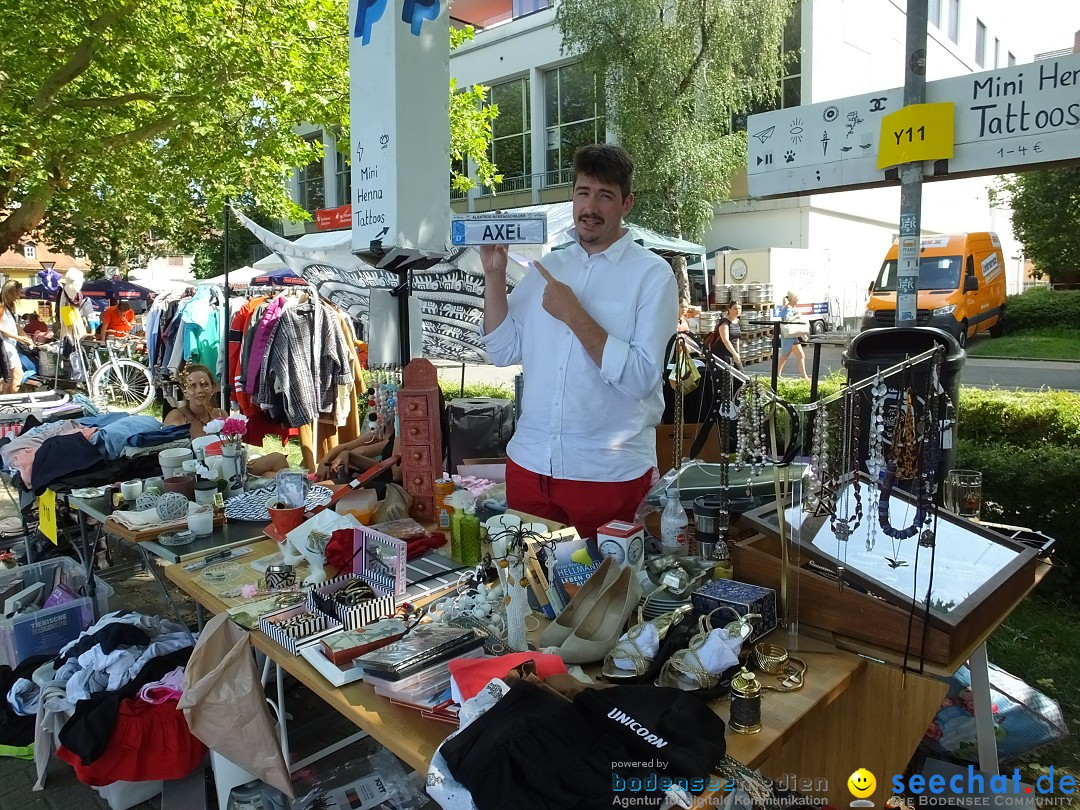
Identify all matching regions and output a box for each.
[481,144,678,546]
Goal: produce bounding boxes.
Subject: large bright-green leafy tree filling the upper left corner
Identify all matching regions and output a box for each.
[0,0,496,264]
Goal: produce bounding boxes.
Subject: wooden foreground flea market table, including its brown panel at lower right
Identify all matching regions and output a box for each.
[164,540,963,804]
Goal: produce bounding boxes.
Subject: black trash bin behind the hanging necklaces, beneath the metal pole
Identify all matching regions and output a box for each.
[843,326,967,503]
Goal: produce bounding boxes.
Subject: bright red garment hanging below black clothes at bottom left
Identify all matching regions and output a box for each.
[56,698,206,787]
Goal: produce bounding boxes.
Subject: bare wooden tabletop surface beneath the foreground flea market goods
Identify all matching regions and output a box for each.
[164,540,866,772]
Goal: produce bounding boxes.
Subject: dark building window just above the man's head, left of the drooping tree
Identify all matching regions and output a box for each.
[544,63,607,186]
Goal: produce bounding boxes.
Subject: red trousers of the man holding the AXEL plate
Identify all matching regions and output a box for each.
[507,459,656,538]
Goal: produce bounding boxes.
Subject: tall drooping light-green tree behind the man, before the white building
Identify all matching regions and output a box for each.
[556,0,797,240]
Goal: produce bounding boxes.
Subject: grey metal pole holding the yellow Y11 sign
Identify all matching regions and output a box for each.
[896,0,928,326]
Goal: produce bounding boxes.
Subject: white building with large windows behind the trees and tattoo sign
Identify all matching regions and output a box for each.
[286,0,1031,318]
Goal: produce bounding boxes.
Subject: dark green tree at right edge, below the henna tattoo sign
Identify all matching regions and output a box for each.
[991,167,1080,283]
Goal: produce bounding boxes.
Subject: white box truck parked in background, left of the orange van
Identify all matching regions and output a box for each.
[714,247,839,335]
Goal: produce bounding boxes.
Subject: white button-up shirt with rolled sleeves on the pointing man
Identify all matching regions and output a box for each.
[483,230,678,482]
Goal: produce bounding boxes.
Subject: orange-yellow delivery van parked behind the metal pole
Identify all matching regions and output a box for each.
[863,231,1005,346]
